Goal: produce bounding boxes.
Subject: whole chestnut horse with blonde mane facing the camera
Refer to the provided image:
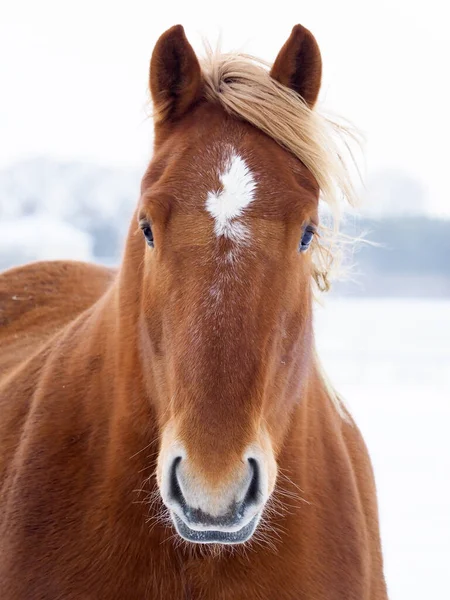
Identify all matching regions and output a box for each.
[0,25,387,600]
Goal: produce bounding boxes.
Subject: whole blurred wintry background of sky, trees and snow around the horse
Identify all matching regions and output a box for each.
[0,0,450,600]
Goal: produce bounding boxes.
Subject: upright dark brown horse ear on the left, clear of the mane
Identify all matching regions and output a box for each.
[150,25,202,121]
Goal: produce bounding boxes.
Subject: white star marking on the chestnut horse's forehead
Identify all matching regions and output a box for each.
[206,154,256,243]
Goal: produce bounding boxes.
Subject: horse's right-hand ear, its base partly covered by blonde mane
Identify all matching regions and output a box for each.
[270,25,322,108]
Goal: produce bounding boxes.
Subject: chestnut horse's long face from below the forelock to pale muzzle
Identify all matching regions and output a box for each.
[136,25,324,544]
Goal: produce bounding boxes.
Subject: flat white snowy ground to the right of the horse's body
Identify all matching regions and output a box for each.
[316,299,450,600]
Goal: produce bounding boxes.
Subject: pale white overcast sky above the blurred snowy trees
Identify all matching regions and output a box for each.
[0,0,450,216]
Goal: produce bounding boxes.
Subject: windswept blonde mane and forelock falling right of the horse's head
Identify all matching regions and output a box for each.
[201,46,360,290]
